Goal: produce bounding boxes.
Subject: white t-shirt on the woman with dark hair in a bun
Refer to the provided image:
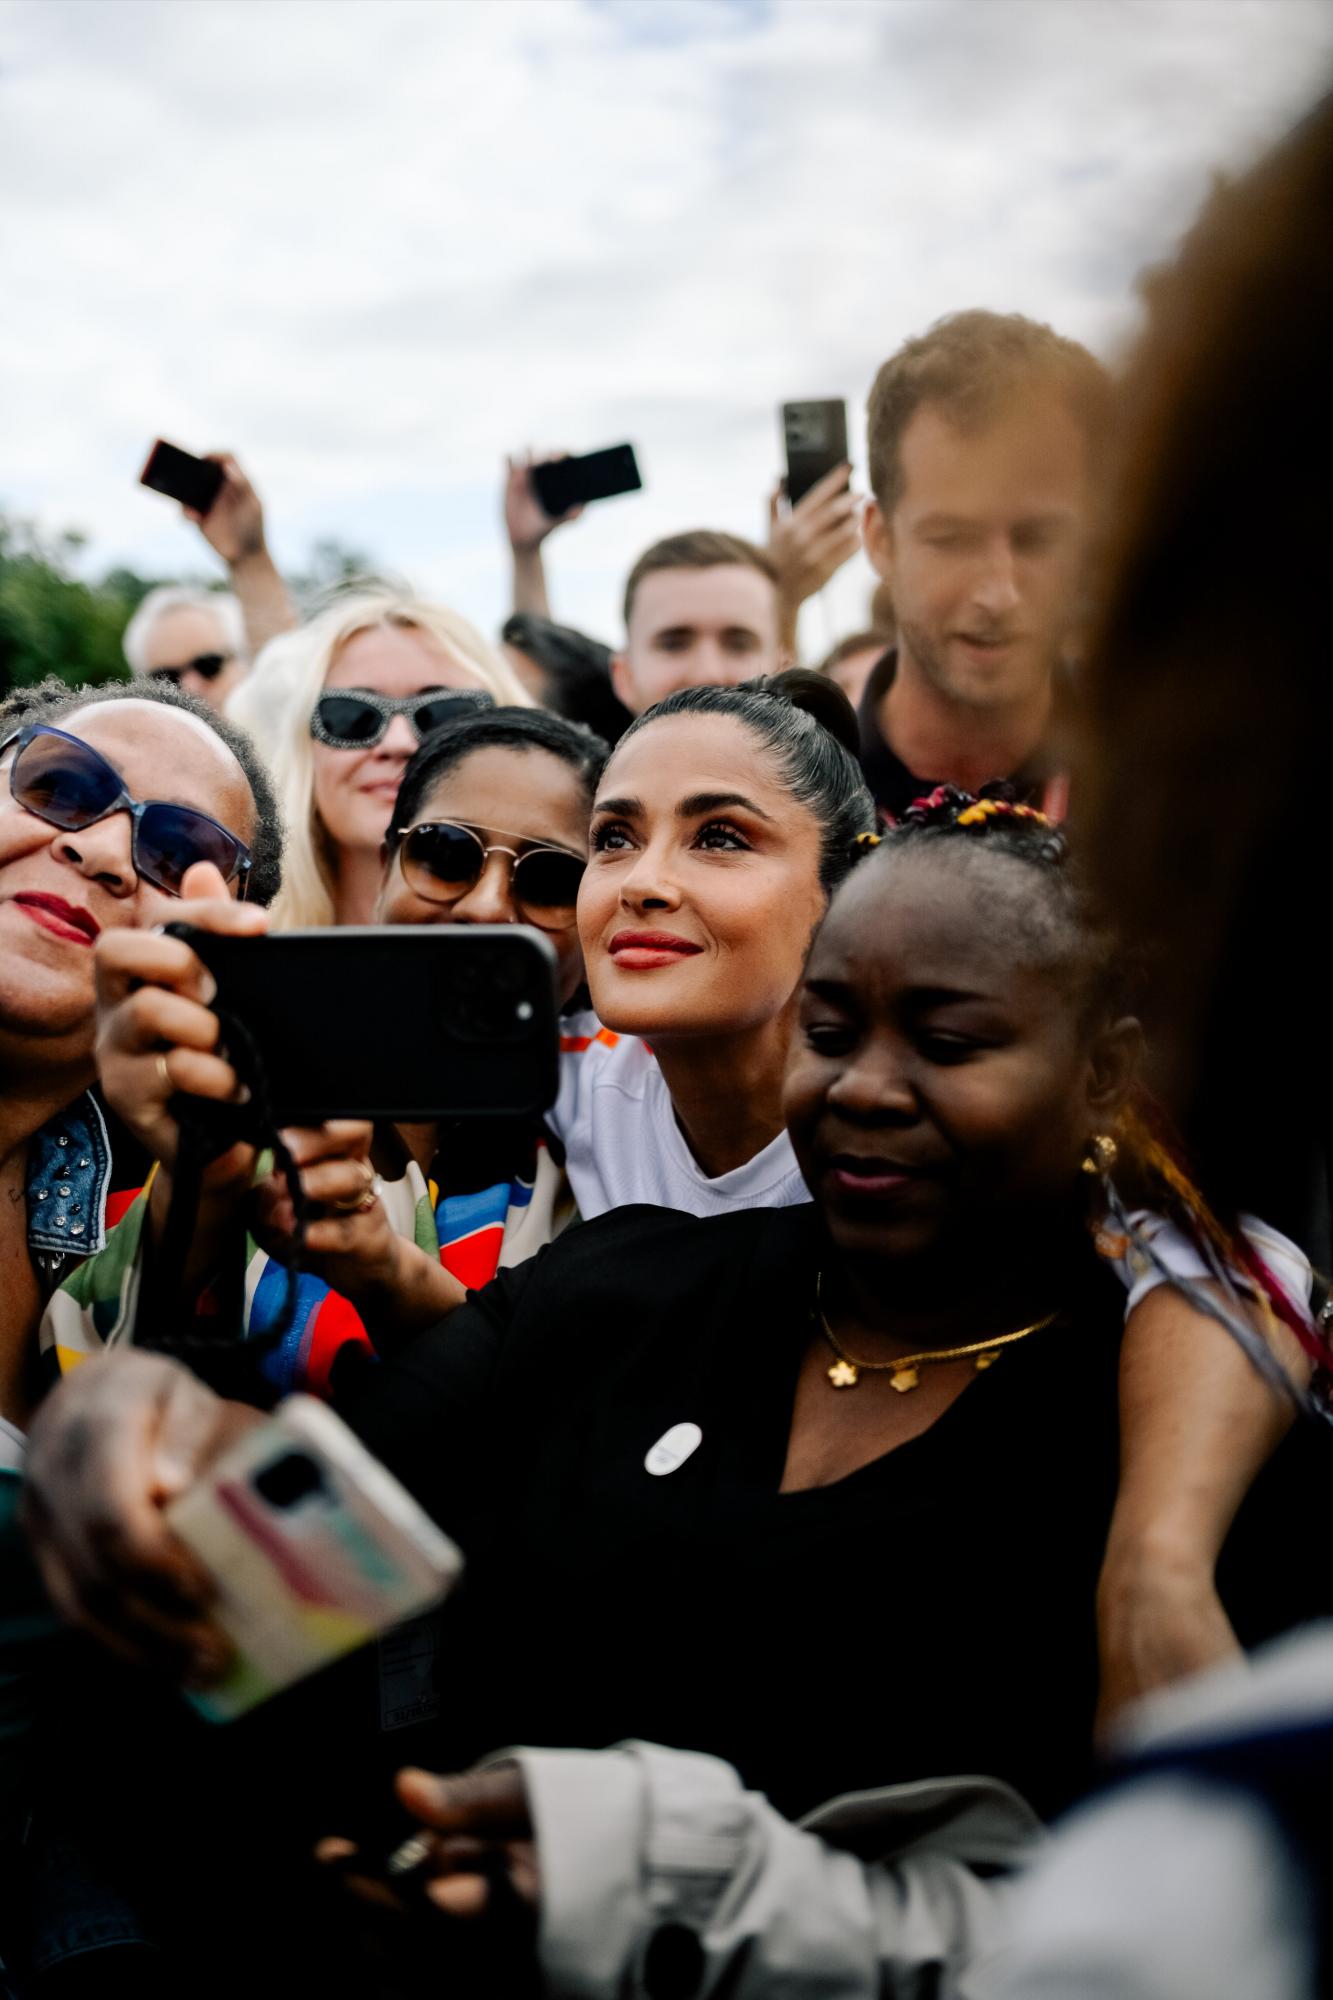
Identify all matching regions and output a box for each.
[546,1014,811,1222]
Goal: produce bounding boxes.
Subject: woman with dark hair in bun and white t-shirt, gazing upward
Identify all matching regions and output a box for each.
[550,668,875,1220]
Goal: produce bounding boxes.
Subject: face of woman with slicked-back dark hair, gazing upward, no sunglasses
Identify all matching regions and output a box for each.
[578,714,825,1044]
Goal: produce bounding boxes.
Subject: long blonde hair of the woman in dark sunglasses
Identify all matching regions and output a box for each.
[226,590,532,930]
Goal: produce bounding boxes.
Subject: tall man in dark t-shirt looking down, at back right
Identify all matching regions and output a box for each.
[844,312,1109,820]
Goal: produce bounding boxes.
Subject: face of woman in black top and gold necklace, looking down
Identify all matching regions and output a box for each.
[783,850,1137,1268]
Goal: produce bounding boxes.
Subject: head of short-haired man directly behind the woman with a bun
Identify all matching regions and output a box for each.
[610,528,787,716]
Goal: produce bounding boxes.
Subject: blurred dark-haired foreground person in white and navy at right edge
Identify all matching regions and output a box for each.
[972,96,1333,2000]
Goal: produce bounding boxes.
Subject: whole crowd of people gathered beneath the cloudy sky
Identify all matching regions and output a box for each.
[0,86,1333,2000]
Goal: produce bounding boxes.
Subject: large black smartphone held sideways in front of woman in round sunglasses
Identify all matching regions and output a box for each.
[166,924,558,1132]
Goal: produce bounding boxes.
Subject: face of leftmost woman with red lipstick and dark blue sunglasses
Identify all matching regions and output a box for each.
[0,698,254,1048]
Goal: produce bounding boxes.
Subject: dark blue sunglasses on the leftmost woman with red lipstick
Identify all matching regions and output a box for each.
[0,722,250,896]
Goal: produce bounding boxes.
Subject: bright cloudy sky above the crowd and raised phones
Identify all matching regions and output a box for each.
[0,0,1333,648]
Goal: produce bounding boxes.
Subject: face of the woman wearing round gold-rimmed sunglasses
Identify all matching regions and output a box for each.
[376,744,588,1004]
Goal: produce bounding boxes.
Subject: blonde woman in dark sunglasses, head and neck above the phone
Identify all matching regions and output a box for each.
[228,588,532,930]
